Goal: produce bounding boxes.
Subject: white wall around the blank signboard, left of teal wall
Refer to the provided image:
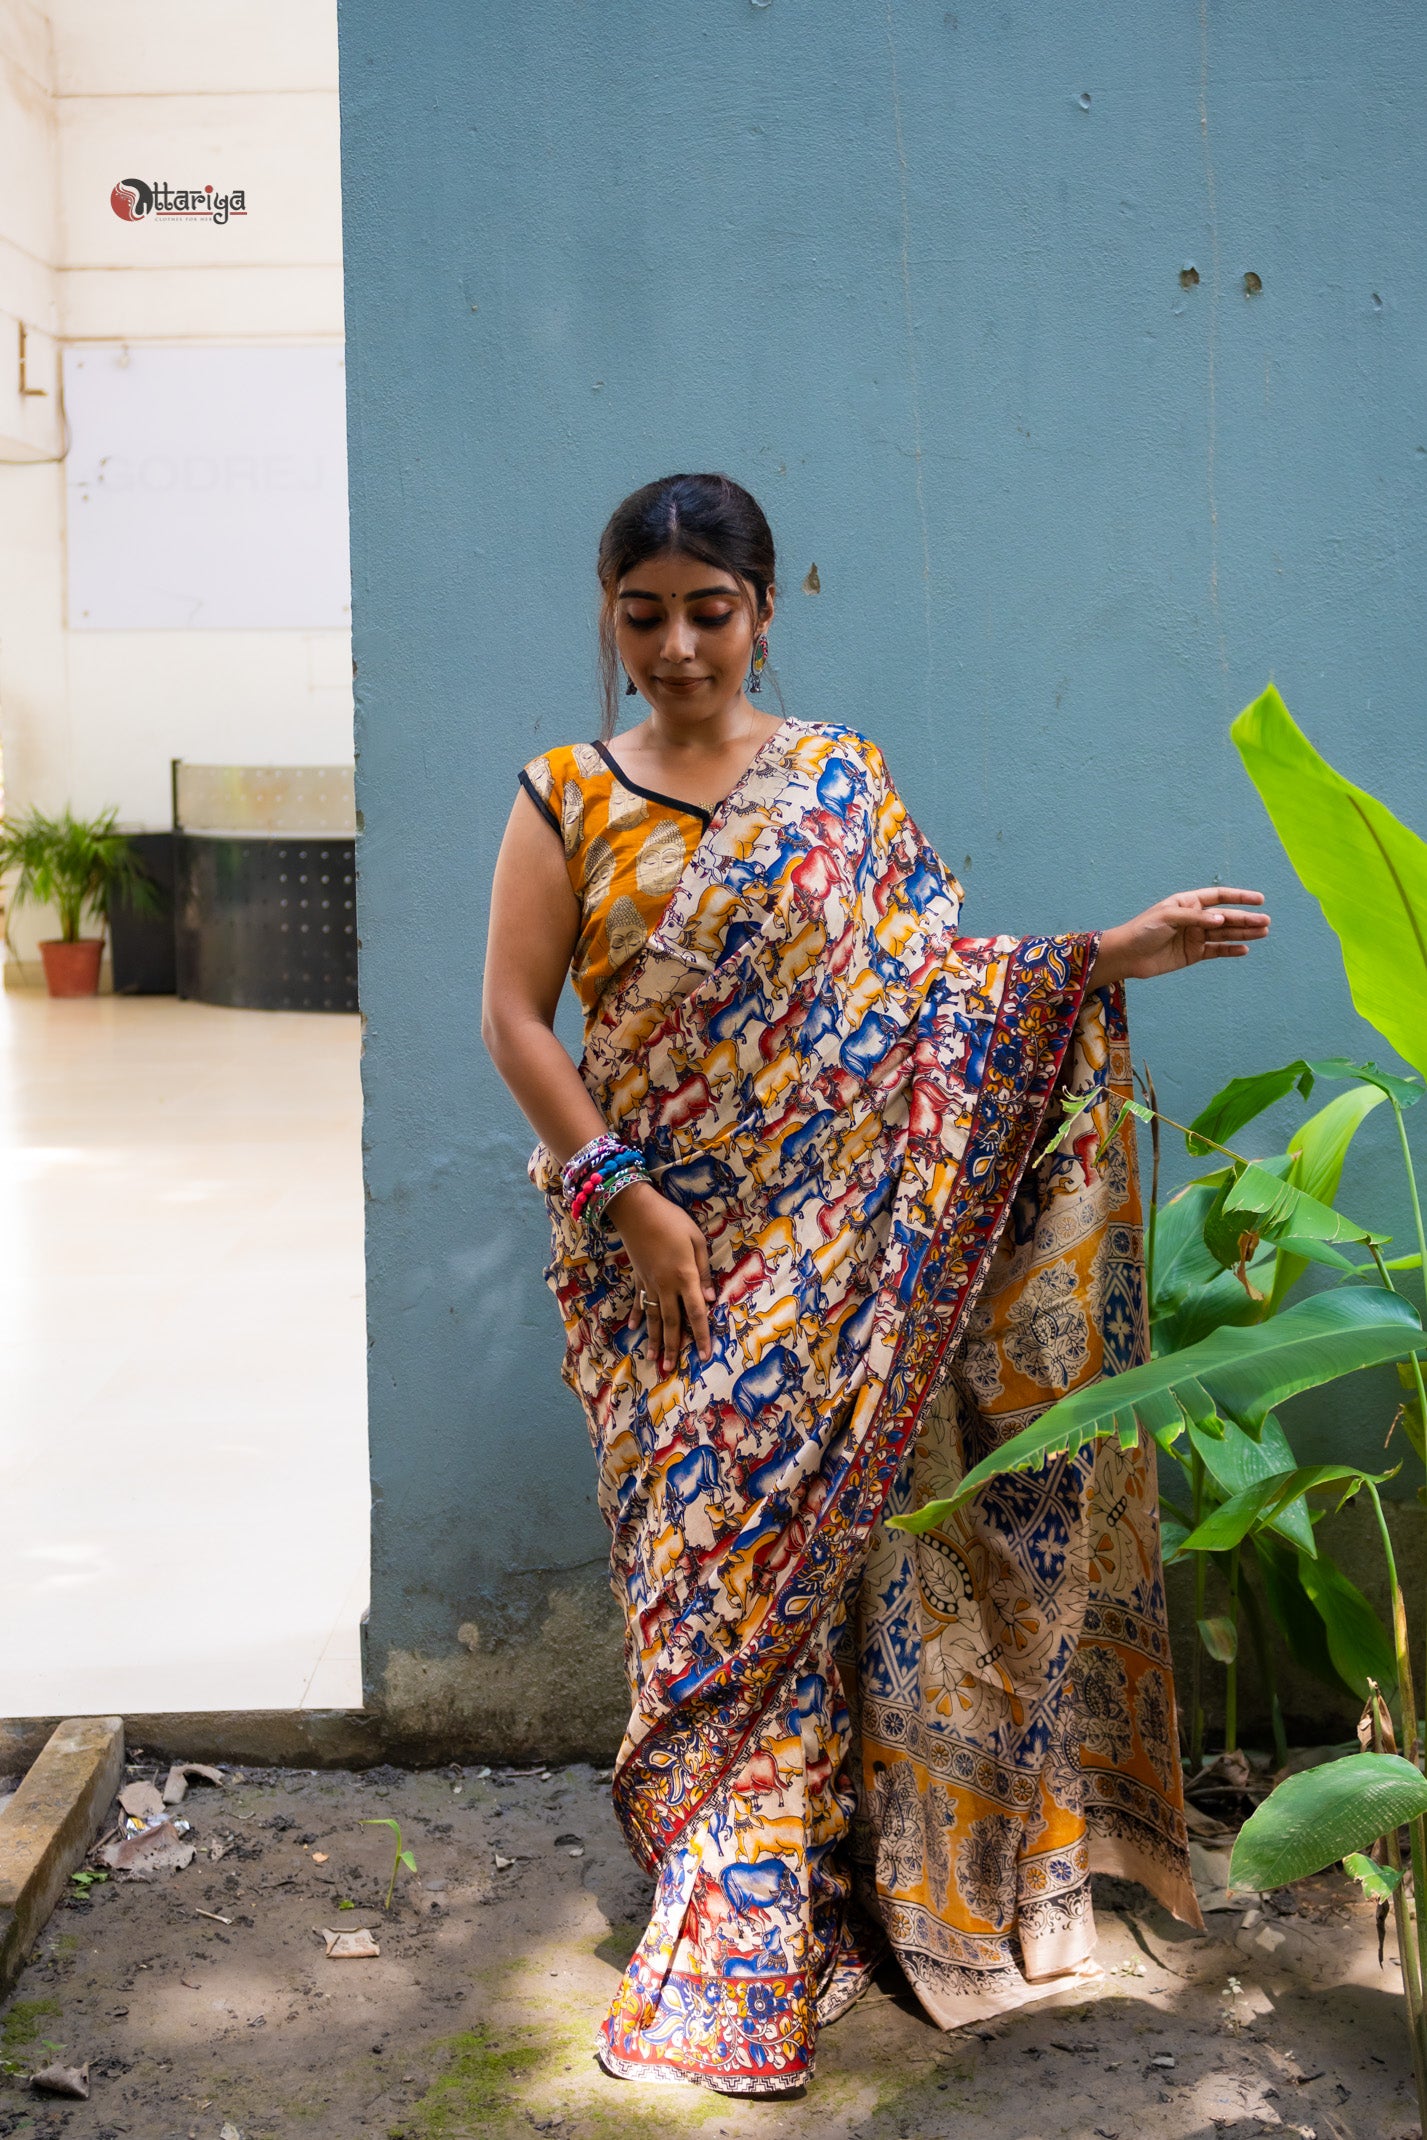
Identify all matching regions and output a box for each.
[0,0,351,950]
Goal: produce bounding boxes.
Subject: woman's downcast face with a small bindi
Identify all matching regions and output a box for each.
[614,550,772,721]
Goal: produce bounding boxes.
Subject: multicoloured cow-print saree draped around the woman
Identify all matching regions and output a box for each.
[531,723,1192,2093]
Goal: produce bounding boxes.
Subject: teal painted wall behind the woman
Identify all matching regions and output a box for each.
[340,0,1427,1744]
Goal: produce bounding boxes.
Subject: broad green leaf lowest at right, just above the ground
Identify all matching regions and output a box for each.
[1228,1753,1427,1890]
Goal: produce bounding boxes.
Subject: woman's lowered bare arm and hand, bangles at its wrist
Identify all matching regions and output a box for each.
[481,788,715,1372]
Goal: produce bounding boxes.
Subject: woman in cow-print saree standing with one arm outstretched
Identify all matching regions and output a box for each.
[484,475,1269,2095]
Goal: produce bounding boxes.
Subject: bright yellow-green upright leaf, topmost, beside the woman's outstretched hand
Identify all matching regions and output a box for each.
[1230,685,1427,1072]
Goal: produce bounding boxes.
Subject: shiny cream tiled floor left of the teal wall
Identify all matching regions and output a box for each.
[0,991,368,1716]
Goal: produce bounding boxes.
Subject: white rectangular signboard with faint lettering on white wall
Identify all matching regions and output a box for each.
[64,342,351,631]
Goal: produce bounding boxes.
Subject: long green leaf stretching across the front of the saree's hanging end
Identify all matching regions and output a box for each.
[888,1286,1423,1530]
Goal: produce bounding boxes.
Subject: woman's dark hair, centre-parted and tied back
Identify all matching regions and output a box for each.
[597,475,783,738]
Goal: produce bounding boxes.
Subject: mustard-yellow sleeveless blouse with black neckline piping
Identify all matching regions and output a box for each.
[520,743,710,1010]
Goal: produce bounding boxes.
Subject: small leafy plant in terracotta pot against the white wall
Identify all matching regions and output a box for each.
[0,809,158,995]
